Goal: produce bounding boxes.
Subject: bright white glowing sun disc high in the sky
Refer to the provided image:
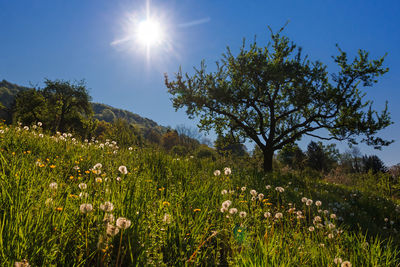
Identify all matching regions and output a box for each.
[136,18,164,47]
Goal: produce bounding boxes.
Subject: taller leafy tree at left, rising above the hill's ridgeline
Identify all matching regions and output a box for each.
[41,79,92,132]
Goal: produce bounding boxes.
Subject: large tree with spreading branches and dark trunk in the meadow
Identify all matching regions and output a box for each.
[165,29,392,174]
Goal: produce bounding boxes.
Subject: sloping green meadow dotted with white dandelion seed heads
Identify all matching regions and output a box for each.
[0,125,400,266]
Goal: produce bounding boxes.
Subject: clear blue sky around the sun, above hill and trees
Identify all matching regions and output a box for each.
[0,0,400,165]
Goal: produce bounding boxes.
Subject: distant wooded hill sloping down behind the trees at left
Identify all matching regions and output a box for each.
[0,80,167,133]
